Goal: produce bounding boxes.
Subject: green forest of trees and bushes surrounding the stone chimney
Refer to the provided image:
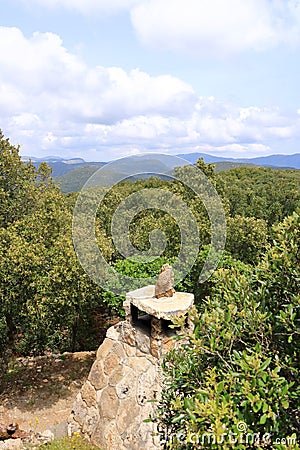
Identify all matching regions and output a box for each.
[0,131,300,449]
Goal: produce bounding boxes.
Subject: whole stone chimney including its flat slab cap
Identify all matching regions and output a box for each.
[69,286,194,450]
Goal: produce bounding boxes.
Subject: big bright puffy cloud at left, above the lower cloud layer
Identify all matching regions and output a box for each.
[0,27,196,118]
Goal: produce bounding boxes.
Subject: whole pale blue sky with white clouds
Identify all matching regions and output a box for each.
[0,0,300,161]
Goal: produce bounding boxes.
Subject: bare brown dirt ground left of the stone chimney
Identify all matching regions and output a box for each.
[0,352,95,433]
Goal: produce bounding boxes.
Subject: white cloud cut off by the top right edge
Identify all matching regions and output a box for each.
[131,0,300,56]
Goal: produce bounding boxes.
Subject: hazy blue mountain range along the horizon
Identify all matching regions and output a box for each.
[22,152,300,192]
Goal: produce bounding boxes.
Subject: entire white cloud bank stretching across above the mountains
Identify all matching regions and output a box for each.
[0,27,300,160]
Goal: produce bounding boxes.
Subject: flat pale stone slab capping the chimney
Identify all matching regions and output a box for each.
[126,285,194,320]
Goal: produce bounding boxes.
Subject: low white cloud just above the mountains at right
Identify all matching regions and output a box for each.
[85,98,299,156]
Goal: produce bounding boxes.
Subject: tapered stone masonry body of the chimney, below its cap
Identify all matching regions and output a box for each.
[69,321,162,450]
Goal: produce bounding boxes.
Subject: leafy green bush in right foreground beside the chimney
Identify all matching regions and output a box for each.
[158,213,300,449]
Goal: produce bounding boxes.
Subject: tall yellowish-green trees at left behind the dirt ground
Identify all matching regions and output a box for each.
[0,135,109,364]
